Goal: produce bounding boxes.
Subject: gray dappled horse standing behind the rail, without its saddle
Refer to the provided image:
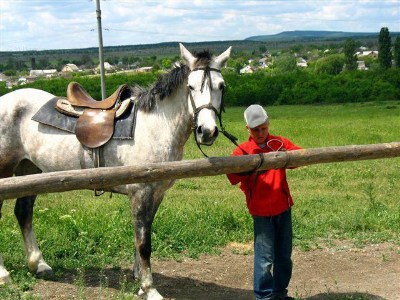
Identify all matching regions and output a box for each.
[0,44,231,299]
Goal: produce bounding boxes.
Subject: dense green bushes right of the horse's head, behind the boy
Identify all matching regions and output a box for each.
[225,68,400,106]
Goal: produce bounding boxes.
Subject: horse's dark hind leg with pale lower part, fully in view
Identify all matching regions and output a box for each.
[14,160,53,276]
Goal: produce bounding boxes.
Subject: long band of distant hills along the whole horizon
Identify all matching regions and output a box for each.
[0,30,400,71]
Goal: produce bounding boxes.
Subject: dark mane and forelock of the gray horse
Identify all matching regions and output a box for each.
[132,50,212,112]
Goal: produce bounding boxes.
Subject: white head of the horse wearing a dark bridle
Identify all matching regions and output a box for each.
[180,44,231,145]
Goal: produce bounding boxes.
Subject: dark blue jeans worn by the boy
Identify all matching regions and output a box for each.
[253,209,293,300]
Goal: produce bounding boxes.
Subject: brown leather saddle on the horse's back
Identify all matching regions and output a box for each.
[55,82,132,148]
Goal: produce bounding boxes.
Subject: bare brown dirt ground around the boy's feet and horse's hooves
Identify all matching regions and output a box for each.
[34,243,400,300]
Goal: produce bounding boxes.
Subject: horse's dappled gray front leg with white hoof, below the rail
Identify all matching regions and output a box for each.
[131,185,164,300]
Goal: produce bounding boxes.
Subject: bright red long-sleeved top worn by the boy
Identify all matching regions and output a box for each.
[227,135,301,216]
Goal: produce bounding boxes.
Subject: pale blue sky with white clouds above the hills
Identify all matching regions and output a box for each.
[0,0,400,51]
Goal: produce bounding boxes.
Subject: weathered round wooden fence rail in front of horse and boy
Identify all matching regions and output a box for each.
[0,142,400,200]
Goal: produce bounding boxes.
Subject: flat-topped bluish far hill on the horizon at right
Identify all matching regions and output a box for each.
[245,30,400,42]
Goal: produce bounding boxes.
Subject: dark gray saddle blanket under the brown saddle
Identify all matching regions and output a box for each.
[32,97,137,140]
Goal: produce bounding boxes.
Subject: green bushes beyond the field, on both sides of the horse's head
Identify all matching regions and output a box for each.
[0,68,400,106]
